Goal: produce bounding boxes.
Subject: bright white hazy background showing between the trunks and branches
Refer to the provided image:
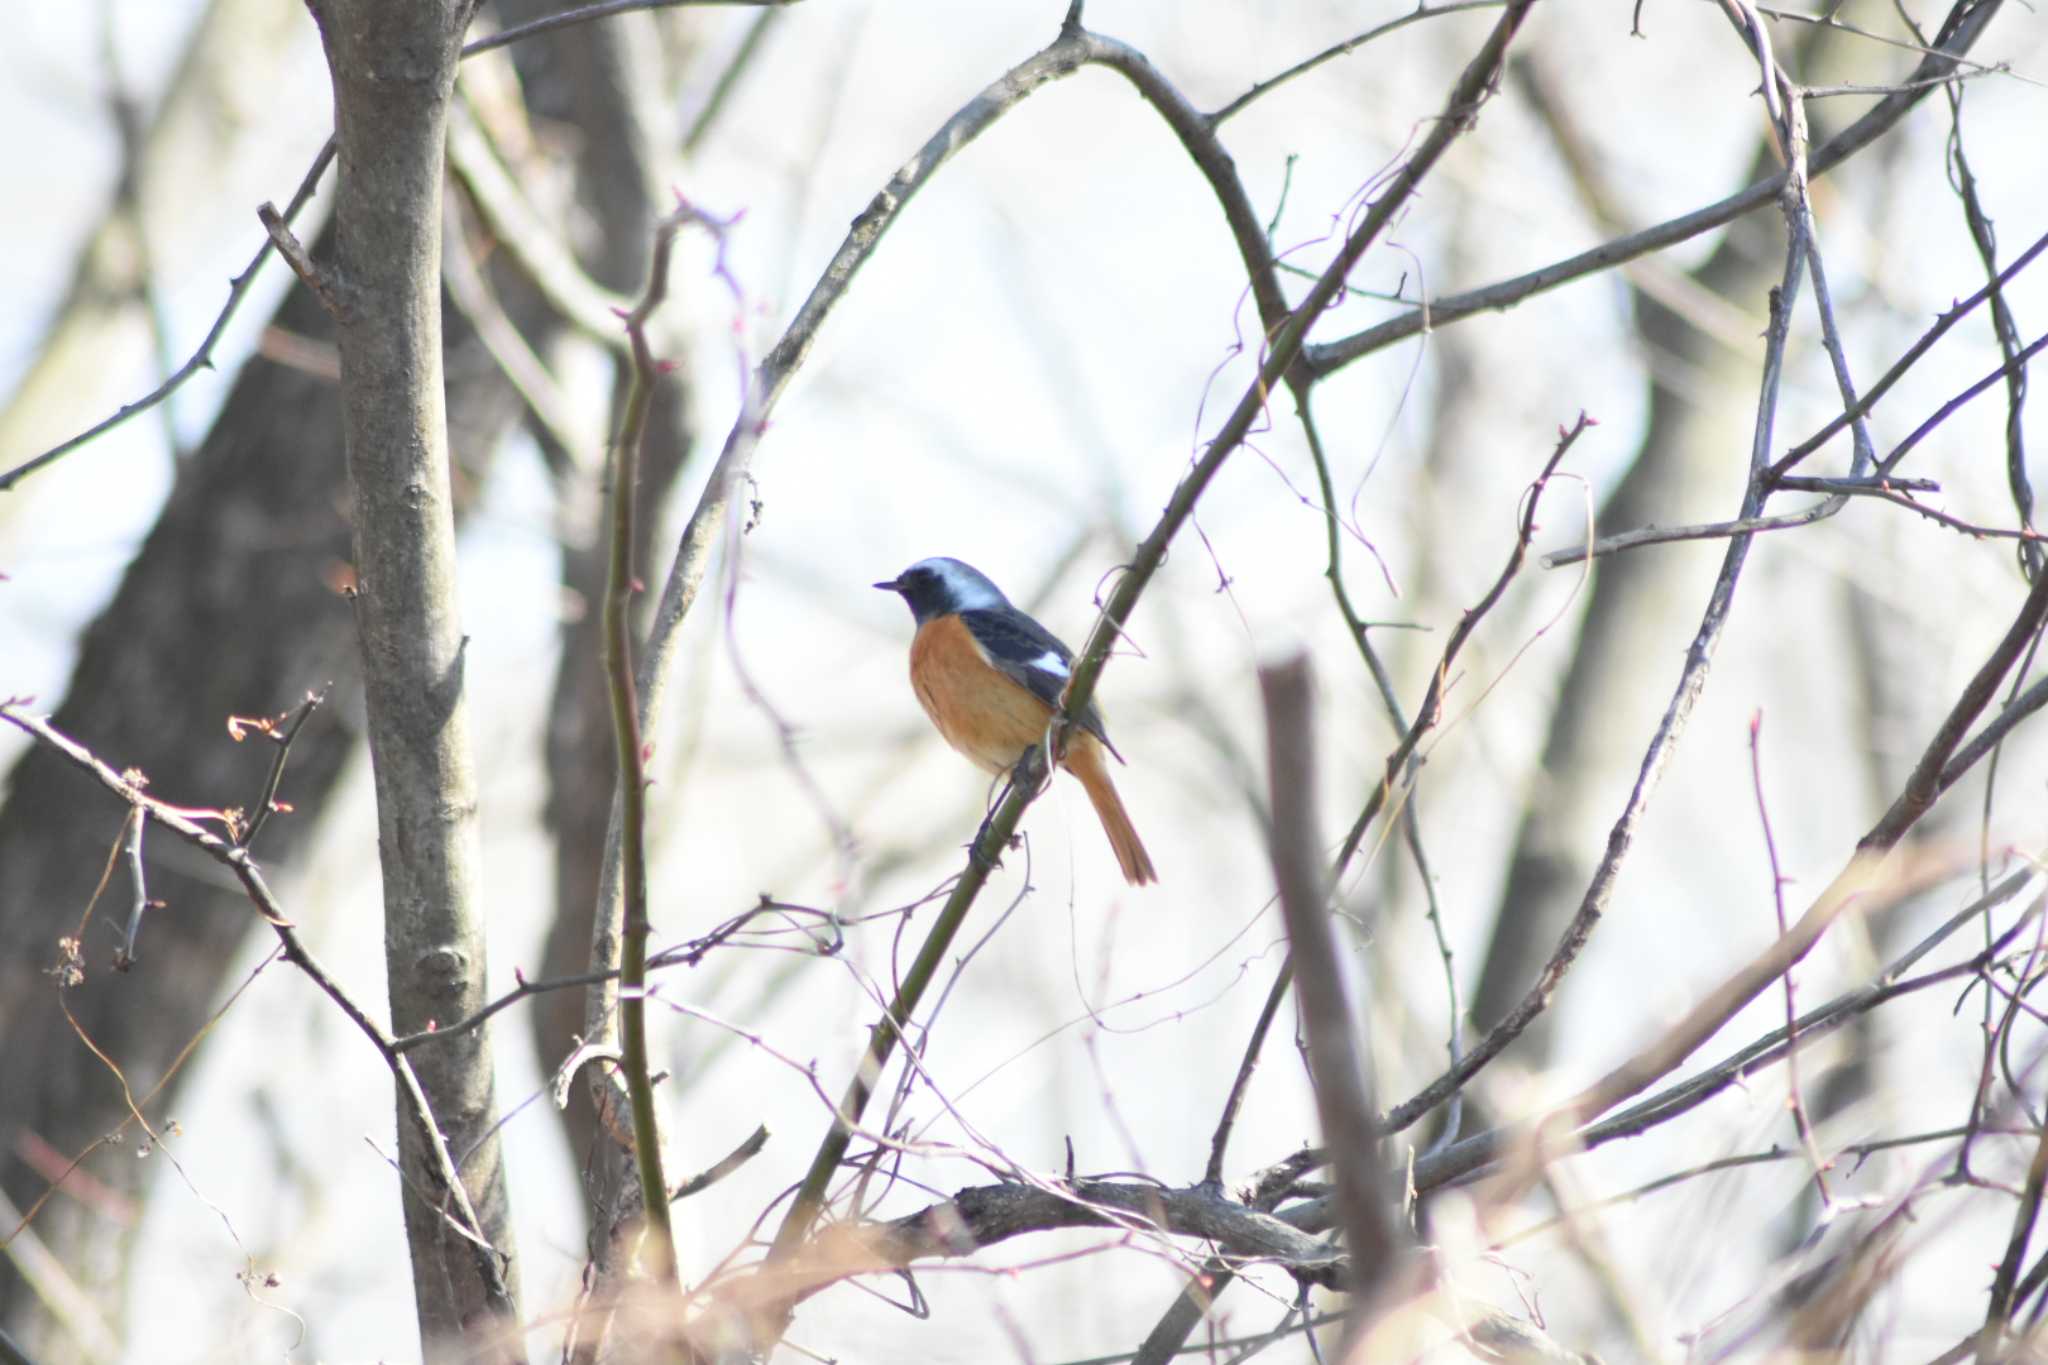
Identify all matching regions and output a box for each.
[0,0,2048,1361]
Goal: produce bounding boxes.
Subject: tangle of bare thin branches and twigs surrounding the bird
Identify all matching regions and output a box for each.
[0,0,2048,1361]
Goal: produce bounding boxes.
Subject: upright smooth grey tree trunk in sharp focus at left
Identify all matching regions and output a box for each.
[313,0,518,1361]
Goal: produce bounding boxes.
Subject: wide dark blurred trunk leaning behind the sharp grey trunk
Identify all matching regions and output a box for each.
[0,227,518,1365]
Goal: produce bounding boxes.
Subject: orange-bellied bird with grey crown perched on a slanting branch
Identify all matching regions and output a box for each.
[877,559,1159,886]
